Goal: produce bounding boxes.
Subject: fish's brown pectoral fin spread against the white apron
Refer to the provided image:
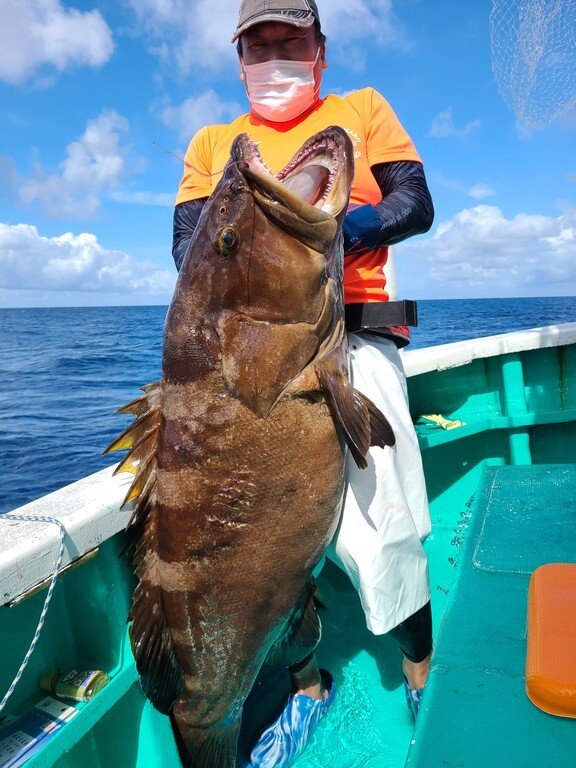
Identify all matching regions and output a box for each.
[315,357,396,469]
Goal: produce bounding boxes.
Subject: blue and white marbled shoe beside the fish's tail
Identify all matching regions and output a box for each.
[250,669,336,768]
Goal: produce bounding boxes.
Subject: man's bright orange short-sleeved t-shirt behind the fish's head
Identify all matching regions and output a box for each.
[176,88,420,304]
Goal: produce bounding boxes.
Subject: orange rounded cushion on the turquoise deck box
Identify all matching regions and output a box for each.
[526,563,576,717]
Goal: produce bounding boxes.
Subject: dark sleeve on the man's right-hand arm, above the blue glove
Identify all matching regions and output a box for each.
[371,160,434,245]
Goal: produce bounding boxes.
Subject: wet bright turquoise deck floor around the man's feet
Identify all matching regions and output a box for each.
[237,526,457,768]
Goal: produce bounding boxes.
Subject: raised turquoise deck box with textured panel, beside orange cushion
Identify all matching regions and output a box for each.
[407,464,576,768]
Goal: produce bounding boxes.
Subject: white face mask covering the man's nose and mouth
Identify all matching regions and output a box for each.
[243,49,320,123]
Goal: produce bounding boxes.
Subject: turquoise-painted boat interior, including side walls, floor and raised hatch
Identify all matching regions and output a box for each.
[0,332,576,768]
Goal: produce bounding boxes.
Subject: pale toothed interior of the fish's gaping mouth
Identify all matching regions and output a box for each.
[243,134,342,215]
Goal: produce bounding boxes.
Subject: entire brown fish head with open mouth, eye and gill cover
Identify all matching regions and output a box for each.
[163,127,354,402]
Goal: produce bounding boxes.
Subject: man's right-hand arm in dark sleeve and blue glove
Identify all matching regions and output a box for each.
[343,160,434,253]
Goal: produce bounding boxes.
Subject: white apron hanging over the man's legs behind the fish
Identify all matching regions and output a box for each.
[330,333,430,635]
